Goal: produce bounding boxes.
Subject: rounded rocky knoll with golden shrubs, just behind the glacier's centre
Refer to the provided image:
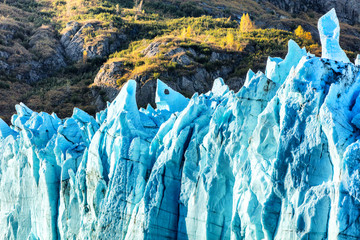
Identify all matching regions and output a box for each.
[94,38,244,107]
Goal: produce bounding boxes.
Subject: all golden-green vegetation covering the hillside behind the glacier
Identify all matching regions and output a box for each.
[0,0,360,122]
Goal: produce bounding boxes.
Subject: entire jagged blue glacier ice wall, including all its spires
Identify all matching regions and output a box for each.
[0,8,360,239]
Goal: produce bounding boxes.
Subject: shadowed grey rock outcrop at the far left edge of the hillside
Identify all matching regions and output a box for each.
[0,21,67,83]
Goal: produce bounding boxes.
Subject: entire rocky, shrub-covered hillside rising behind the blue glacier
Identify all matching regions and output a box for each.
[0,0,360,122]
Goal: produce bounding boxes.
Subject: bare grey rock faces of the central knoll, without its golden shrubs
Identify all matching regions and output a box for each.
[94,41,244,109]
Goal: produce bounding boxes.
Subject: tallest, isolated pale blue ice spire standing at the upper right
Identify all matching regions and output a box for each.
[318,9,350,63]
